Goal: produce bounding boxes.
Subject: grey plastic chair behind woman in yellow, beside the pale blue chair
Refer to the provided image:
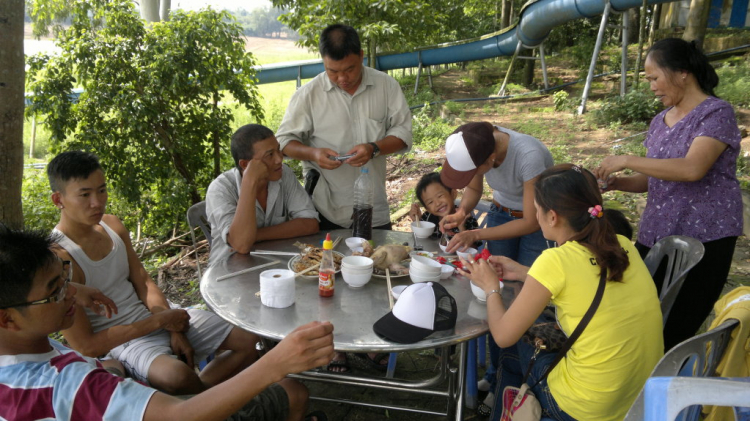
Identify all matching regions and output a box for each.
[625,320,739,421]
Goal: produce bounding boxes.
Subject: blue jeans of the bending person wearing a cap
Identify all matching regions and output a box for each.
[484,204,547,390]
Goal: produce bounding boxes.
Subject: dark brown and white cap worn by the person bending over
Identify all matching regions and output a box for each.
[440,122,495,189]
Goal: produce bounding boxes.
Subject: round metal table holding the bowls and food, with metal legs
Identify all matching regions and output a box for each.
[200,230,508,420]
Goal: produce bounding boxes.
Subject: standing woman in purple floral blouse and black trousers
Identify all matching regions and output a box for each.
[595,38,742,349]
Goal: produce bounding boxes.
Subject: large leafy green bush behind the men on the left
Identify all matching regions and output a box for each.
[27,0,263,235]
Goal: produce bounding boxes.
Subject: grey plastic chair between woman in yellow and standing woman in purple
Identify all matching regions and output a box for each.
[643,235,705,326]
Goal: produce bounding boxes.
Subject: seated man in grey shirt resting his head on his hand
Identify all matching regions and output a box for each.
[206,124,318,264]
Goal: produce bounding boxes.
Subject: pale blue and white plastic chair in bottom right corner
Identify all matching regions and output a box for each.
[643,377,750,421]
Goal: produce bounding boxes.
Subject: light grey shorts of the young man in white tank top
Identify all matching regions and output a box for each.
[107,309,234,384]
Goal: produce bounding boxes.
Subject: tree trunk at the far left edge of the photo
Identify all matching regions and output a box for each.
[0,0,26,229]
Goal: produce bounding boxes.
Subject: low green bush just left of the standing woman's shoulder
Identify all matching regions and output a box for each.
[593,90,661,126]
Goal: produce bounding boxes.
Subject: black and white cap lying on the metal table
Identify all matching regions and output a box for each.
[372,282,458,344]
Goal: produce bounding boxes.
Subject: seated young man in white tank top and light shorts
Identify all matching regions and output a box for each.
[47,151,258,395]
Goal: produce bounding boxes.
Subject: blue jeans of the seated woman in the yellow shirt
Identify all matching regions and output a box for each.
[490,341,576,421]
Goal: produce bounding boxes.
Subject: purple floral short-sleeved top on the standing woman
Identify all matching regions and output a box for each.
[638,97,742,247]
